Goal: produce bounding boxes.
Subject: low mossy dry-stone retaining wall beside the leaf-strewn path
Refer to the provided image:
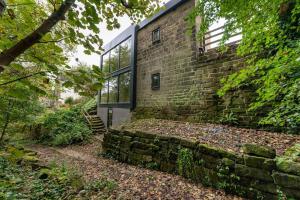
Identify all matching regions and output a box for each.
[103,130,300,200]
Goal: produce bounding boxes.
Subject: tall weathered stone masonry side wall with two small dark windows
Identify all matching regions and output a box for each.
[136,0,253,125]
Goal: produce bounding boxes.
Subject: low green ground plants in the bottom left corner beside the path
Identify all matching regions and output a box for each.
[0,150,83,200]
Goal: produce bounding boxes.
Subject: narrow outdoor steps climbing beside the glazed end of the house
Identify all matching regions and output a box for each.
[83,106,107,135]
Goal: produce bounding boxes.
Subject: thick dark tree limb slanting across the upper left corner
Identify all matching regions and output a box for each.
[0,0,75,73]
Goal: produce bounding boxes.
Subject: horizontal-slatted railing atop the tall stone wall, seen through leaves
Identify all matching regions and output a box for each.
[202,26,242,51]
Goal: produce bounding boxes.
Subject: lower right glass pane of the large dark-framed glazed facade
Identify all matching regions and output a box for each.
[119,72,130,103]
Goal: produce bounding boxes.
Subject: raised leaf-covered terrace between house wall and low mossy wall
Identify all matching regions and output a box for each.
[117,119,300,155]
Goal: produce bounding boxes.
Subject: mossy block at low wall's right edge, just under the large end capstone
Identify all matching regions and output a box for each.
[272,172,300,189]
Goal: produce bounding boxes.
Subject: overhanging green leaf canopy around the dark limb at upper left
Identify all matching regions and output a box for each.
[0,0,162,96]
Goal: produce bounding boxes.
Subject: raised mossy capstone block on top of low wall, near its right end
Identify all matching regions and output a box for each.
[243,144,276,159]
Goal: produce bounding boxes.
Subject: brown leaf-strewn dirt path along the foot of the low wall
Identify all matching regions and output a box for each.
[30,140,241,200]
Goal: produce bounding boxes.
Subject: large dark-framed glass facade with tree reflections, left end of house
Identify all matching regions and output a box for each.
[100,38,131,105]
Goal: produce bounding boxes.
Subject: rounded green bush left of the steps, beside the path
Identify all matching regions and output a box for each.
[39,107,92,145]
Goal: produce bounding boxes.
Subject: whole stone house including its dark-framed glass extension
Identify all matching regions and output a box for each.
[97,0,252,126]
